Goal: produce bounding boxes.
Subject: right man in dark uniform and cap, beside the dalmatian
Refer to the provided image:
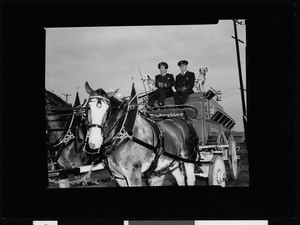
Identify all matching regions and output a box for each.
[172,60,195,105]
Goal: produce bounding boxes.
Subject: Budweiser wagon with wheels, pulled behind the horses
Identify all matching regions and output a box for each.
[146,89,239,187]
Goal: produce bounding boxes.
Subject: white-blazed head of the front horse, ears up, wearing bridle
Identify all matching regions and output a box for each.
[85,82,118,149]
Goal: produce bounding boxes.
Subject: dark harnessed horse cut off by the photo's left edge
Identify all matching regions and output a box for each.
[45,90,90,173]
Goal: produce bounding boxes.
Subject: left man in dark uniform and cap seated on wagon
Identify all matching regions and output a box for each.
[148,62,175,107]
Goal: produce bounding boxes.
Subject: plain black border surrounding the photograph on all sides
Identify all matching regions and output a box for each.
[0,0,296,224]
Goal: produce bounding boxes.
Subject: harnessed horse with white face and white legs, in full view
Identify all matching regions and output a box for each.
[85,82,198,187]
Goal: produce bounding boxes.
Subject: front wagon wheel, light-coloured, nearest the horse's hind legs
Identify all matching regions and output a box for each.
[208,155,226,187]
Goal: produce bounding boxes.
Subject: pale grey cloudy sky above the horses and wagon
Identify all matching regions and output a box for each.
[45,20,246,131]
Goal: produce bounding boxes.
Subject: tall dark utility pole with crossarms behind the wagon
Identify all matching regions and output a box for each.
[231,20,247,137]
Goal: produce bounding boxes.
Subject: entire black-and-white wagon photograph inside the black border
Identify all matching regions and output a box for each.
[45,19,249,188]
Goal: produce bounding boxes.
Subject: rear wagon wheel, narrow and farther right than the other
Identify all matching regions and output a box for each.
[228,134,238,180]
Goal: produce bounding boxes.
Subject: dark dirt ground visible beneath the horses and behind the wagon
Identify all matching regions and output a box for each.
[49,148,249,188]
